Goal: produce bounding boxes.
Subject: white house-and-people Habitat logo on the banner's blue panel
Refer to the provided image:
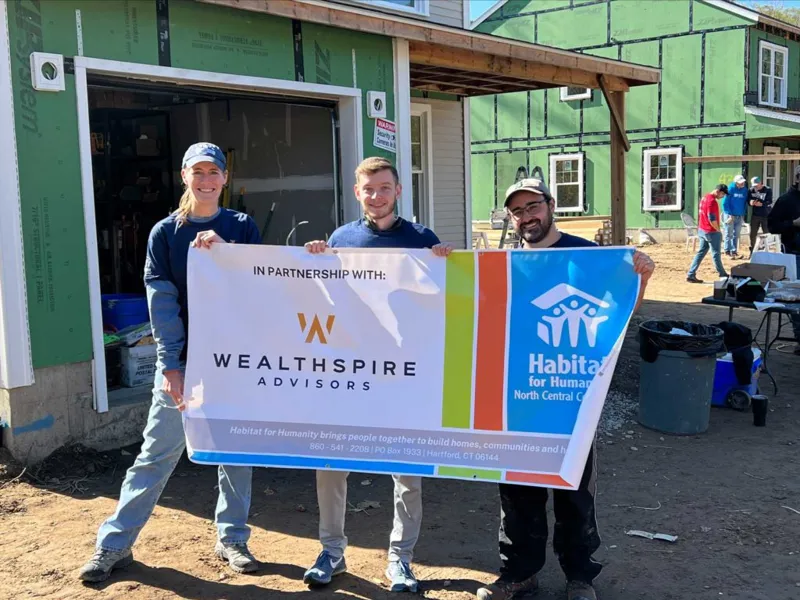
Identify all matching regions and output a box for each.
[531,283,610,348]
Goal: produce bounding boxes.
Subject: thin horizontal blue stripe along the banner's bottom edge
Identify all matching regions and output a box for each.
[189,451,435,475]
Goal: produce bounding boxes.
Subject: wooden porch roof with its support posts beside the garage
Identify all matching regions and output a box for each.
[198,0,660,247]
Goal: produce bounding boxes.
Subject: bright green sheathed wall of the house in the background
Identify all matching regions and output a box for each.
[471,0,756,228]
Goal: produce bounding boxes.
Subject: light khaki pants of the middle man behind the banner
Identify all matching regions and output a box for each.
[317,471,422,564]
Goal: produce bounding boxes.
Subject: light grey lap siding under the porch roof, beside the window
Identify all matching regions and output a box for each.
[411,97,467,248]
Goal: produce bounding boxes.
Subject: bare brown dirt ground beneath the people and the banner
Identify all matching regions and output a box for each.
[0,245,800,600]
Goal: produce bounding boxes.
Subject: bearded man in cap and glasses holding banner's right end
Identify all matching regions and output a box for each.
[477,178,655,600]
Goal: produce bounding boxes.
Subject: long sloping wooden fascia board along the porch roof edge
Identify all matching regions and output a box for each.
[197,0,661,89]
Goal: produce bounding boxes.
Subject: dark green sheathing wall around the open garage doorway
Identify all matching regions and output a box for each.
[8,0,394,368]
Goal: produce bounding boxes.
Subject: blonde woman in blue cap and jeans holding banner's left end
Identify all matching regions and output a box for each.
[79,143,261,582]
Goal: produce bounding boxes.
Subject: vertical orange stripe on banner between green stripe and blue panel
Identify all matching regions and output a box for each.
[474,252,508,431]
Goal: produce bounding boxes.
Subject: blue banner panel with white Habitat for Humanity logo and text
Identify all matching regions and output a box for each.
[506,248,638,434]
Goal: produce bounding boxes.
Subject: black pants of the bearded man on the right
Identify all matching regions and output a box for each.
[499,445,603,583]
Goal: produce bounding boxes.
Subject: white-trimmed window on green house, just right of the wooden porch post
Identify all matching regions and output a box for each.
[642,148,683,211]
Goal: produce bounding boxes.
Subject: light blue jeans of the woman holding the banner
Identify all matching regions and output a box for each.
[97,371,253,550]
